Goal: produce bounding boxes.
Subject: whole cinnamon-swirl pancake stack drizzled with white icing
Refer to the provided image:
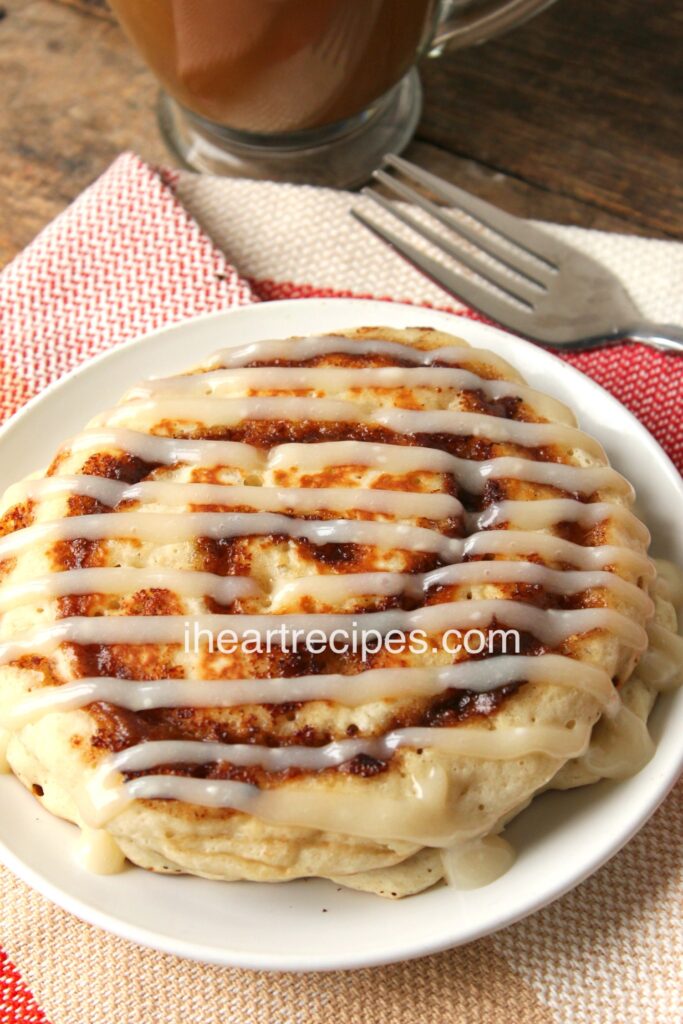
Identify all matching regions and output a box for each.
[0,327,683,897]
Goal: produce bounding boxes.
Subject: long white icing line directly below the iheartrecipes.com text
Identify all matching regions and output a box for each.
[0,654,621,728]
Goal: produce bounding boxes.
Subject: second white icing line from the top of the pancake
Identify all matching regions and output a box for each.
[126,367,575,426]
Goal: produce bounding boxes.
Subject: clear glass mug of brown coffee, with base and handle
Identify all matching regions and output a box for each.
[110,0,552,187]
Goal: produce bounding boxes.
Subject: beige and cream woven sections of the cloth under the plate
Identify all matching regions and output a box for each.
[0,159,683,1024]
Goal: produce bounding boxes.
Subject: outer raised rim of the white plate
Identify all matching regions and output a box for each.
[0,298,683,973]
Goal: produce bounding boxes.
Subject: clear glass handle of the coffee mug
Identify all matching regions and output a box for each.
[430,0,555,50]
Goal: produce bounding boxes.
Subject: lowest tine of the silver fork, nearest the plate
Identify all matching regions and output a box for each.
[350,209,528,334]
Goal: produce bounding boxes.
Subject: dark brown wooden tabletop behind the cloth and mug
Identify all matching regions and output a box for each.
[0,0,683,263]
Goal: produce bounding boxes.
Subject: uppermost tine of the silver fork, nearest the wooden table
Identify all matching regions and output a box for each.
[384,154,559,269]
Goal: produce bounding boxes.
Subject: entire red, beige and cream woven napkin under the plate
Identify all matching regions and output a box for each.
[0,155,683,1024]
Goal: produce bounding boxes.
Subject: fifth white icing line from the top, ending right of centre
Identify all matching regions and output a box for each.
[5,475,463,519]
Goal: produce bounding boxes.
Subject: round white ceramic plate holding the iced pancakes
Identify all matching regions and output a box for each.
[0,299,683,971]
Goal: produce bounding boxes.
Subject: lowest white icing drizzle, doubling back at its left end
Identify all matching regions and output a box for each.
[81,725,591,846]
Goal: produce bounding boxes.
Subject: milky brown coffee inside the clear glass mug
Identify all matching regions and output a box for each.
[111,0,435,133]
